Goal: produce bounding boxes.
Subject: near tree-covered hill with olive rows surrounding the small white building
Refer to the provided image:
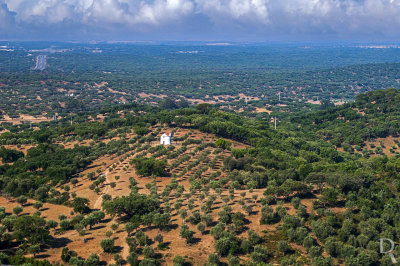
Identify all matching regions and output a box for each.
[0,90,400,265]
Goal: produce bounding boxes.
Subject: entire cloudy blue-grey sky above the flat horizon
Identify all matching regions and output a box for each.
[0,0,400,42]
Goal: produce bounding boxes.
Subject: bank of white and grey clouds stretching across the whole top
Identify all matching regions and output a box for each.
[0,0,400,40]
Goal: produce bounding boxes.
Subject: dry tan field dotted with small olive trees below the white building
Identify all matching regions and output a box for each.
[0,123,332,265]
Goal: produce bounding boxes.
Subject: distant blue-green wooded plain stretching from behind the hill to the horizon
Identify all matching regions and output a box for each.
[0,43,400,117]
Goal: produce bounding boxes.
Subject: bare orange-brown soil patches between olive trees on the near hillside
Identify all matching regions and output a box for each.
[0,128,312,265]
